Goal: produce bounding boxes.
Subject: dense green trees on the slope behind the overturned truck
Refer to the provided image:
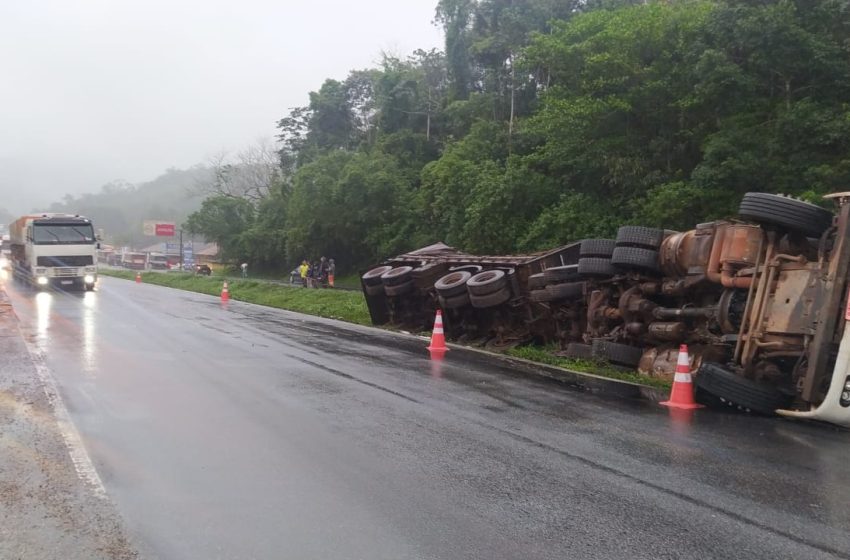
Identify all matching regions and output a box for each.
[189,0,850,269]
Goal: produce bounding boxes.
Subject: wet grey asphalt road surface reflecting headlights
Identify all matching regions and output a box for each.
[7,278,850,560]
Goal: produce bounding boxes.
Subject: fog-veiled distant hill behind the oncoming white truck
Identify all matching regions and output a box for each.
[48,166,210,246]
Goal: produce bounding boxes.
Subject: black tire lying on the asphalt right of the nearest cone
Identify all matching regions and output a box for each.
[694,362,791,416]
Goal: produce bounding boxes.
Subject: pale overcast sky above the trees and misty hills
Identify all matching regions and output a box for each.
[0,0,442,213]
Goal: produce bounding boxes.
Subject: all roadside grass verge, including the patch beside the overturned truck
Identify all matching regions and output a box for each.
[98,269,670,389]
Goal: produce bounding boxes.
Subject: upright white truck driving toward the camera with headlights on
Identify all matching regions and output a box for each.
[9,214,99,290]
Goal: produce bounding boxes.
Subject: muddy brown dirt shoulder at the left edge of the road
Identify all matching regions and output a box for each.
[0,287,138,560]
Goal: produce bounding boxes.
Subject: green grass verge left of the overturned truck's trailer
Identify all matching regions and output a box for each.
[99,269,371,325]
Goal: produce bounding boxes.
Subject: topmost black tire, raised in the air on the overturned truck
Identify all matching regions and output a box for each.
[738,193,832,237]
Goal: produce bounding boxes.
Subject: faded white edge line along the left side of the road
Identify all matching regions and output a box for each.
[21,333,106,500]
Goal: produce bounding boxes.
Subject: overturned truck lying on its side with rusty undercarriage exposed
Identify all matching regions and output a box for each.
[361,193,850,427]
